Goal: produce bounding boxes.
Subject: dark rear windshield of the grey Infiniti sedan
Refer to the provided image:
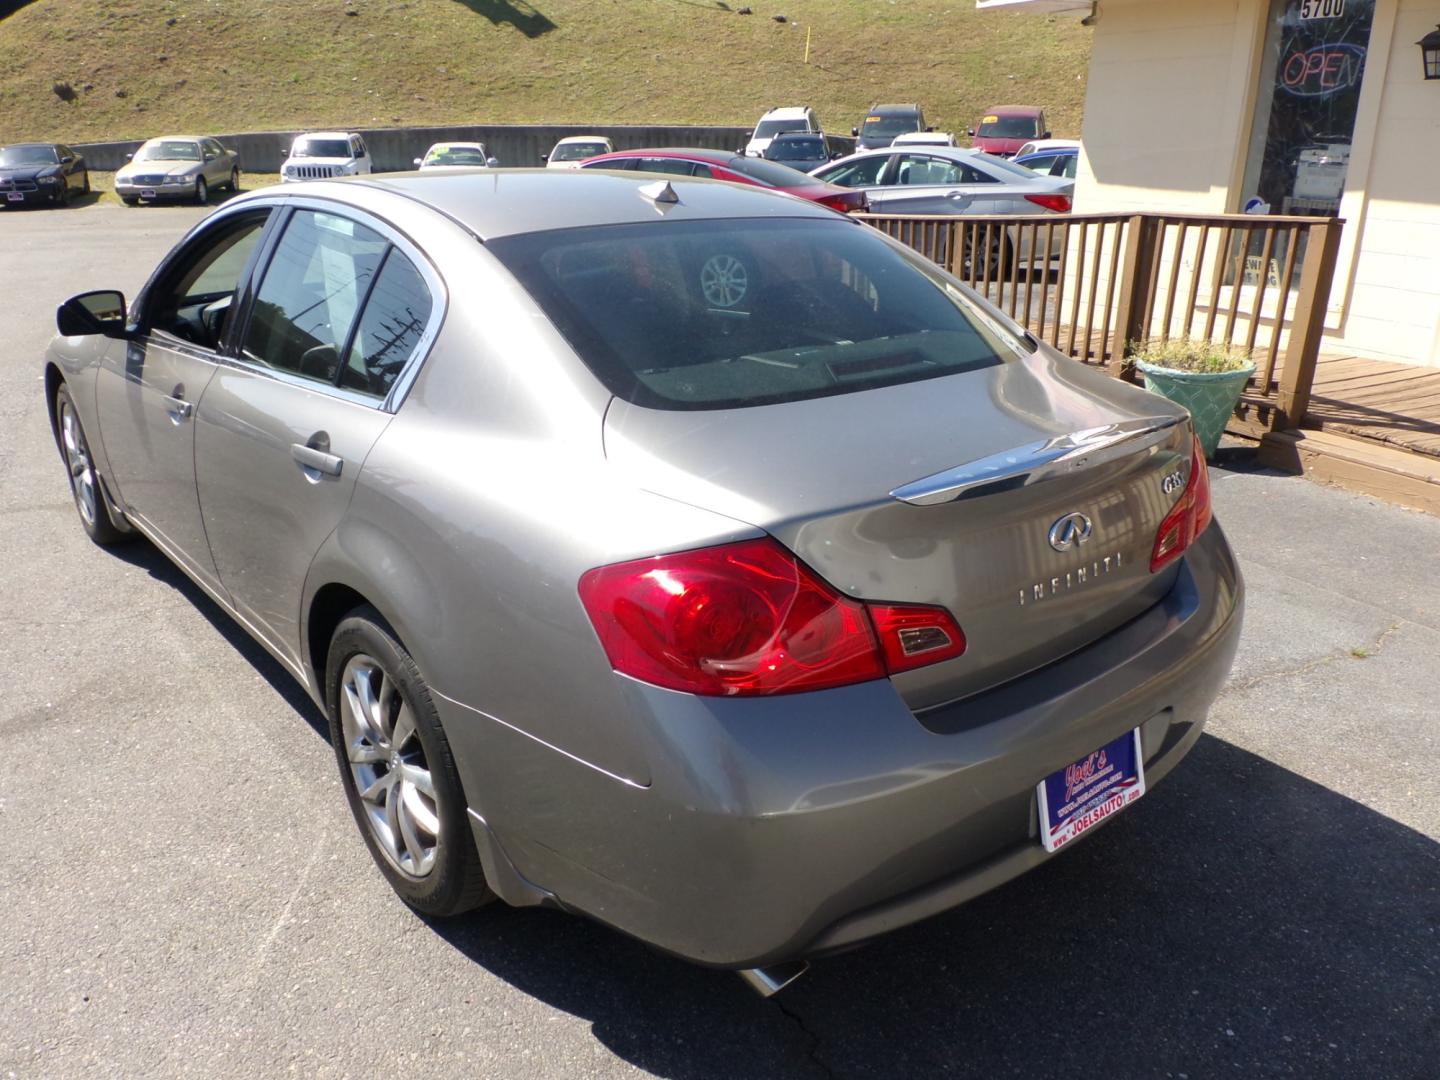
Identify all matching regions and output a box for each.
[487,219,1025,409]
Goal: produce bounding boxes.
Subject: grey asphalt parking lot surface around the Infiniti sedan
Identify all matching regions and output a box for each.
[0,207,1440,1080]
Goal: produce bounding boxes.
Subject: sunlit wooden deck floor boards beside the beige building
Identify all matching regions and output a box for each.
[1303,356,1440,458]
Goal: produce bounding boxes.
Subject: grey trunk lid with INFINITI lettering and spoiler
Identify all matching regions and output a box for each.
[605,353,1191,710]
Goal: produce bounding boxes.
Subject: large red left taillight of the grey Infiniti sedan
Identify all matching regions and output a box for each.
[580,540,965,696]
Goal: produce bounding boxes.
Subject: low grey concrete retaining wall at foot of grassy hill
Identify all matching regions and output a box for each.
[71,124,854,173]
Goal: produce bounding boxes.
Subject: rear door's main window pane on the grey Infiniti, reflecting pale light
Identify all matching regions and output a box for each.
[242,210,389,383]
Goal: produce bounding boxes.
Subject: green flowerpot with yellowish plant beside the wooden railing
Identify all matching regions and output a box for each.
[1130,337,1256,458]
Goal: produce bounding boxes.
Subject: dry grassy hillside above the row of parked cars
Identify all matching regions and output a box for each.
[0,0,1090,143]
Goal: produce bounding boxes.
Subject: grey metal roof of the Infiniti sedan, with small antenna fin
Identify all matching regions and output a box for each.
[324,168,845,239]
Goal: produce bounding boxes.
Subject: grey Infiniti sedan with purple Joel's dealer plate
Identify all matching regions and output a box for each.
[45,170,1243,991]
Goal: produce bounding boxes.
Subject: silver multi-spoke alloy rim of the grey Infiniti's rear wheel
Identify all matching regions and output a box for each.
[340,652,441,878]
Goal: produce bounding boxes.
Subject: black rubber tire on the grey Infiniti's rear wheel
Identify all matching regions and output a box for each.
[325,606,494,917]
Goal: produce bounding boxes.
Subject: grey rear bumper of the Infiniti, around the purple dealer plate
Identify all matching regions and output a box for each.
[442,526,1243,968]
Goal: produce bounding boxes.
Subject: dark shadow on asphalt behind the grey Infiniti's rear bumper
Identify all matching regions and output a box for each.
[420,736,1440,1080]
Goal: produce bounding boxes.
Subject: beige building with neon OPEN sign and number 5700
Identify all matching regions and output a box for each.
[978,0,1440,367]
